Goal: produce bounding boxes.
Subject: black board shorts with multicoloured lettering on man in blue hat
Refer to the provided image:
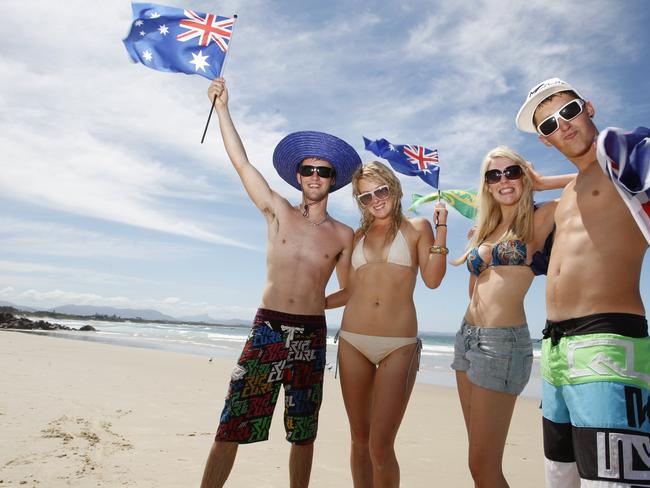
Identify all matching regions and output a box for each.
[215,309,327,444]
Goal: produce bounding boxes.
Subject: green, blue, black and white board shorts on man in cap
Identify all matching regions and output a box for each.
[541,313,650,488]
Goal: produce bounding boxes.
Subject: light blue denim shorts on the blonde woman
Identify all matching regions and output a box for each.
[451,320,533,395]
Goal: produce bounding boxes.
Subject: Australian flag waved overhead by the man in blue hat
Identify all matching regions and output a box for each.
[123,3,236,80]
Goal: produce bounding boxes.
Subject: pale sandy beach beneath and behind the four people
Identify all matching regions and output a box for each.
[0,331,543,488]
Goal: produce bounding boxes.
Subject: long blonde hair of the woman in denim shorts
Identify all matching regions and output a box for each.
[452,146,534,265]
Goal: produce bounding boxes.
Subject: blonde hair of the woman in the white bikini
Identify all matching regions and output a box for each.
[352,161,404,242]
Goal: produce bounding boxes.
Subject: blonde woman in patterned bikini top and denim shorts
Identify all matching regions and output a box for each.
[451,146,574,488]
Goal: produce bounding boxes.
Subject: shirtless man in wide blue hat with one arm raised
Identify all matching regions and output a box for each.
[201,78,361,488]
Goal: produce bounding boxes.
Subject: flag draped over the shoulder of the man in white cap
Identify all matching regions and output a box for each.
[597,127,650,243]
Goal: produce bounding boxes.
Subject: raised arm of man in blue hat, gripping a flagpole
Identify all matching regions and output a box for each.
[208,78,275,210]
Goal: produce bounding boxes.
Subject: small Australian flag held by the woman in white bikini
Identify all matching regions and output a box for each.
[363,137,440,188]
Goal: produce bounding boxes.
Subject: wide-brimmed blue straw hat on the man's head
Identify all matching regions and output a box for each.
[273,131,361,193]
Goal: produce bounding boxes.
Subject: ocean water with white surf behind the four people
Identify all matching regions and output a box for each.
[20,317,541,398]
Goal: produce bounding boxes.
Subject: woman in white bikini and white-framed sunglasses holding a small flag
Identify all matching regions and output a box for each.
[326,161,447,488]
